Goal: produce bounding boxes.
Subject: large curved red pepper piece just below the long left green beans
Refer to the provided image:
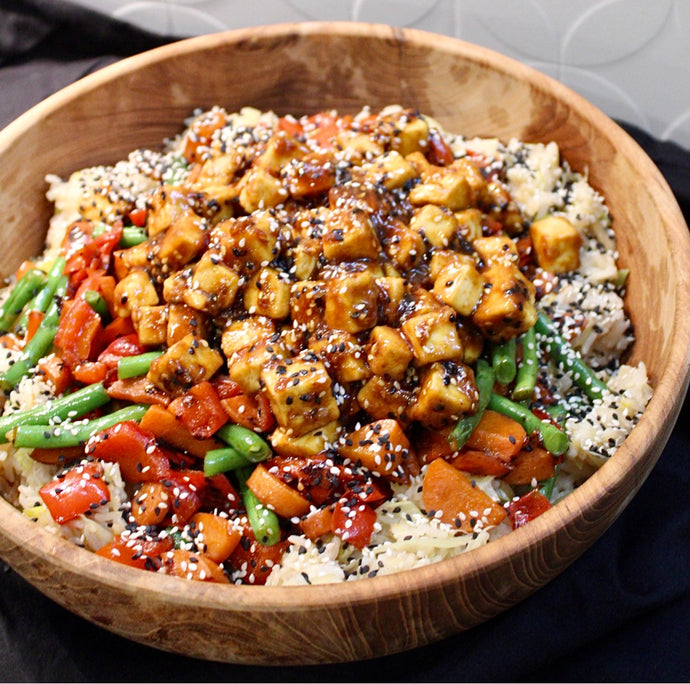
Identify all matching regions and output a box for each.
[86,420,170,482]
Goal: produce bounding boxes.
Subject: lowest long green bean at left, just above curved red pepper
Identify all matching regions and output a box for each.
[14,404,149,449]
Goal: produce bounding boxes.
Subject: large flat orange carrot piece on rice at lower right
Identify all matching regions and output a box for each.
[422,458,507,532]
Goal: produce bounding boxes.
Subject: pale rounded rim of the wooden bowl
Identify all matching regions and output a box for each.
[0,21,690,612]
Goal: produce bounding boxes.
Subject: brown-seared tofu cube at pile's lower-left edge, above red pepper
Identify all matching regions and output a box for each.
[146,334,223,395]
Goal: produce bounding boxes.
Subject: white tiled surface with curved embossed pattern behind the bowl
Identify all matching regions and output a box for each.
[74,0,690,148]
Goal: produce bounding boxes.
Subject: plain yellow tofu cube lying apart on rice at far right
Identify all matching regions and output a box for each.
[529,216,582,273]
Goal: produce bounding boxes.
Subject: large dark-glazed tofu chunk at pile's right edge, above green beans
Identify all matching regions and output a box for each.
[471,264,537,342]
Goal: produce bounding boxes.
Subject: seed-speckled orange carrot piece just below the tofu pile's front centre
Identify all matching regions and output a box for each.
[340,418,419,482]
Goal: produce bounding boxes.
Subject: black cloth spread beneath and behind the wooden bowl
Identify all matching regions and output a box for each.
[0,0,690,682]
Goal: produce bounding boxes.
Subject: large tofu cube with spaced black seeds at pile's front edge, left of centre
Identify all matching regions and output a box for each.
[261,352,340,437]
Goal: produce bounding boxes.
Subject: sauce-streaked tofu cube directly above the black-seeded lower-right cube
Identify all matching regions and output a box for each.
[402,307,463,366]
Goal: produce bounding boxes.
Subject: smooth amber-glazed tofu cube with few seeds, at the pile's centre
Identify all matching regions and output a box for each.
[324,271,378,334]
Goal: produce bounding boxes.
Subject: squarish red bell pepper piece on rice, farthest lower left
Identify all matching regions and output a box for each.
[38,463,110,525]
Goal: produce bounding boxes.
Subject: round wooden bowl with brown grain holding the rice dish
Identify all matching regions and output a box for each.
[0,23,690,665]
